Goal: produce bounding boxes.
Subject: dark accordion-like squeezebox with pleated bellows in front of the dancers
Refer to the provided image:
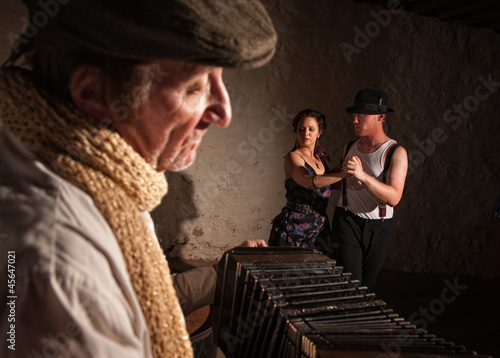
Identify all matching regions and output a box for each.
[211,247,484,358]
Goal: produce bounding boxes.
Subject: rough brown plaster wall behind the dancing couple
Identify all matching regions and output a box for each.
[0,0,500,274]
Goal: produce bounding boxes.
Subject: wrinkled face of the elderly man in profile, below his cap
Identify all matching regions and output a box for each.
[115,60,231,171]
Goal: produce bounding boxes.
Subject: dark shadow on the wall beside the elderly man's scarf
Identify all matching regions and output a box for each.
[151,172,200,257]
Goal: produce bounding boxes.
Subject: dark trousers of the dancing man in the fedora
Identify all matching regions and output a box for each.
[332,207,393,291]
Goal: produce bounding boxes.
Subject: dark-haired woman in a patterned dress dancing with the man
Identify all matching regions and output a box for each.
[269,109,349,251]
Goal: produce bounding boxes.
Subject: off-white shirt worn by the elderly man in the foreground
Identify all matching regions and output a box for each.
[0,128,152,358]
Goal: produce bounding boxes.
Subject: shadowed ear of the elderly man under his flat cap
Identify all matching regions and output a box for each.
[69,65,115,120]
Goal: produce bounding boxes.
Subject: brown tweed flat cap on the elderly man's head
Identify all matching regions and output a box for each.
[23,0,277,68]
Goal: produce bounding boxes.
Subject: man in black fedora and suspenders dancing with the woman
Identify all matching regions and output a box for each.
[332,89,408,291]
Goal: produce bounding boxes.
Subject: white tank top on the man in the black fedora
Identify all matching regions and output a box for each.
[337,139,396,219]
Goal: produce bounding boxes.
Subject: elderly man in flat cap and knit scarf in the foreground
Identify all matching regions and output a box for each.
[0,0,276,358]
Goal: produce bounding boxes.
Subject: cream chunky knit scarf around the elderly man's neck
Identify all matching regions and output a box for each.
[0,69,193,358]
